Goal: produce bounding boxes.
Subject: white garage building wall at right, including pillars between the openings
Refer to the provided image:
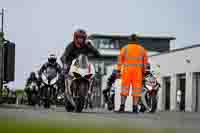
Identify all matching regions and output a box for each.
[149,47,200,112]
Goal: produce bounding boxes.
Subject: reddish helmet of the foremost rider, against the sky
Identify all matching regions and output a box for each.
[74,29,87,48]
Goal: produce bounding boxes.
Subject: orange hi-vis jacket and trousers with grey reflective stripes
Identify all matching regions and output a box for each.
[118,44,148,96]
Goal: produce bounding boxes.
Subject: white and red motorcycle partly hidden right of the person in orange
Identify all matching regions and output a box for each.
[140,72,160,113]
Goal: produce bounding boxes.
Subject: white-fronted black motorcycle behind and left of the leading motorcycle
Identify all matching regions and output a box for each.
[40,68,59,108]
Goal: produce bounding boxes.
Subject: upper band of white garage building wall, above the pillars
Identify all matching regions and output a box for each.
[149,47,200,76]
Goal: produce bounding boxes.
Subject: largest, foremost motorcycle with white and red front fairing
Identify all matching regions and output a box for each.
[65,54,95,112]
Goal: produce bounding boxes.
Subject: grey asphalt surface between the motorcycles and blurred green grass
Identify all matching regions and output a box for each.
[0,105,200,132]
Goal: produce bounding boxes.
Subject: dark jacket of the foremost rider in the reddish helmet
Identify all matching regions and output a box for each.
[61,42,100,66]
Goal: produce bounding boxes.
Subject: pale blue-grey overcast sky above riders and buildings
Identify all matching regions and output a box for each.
[0,0,200,88]
